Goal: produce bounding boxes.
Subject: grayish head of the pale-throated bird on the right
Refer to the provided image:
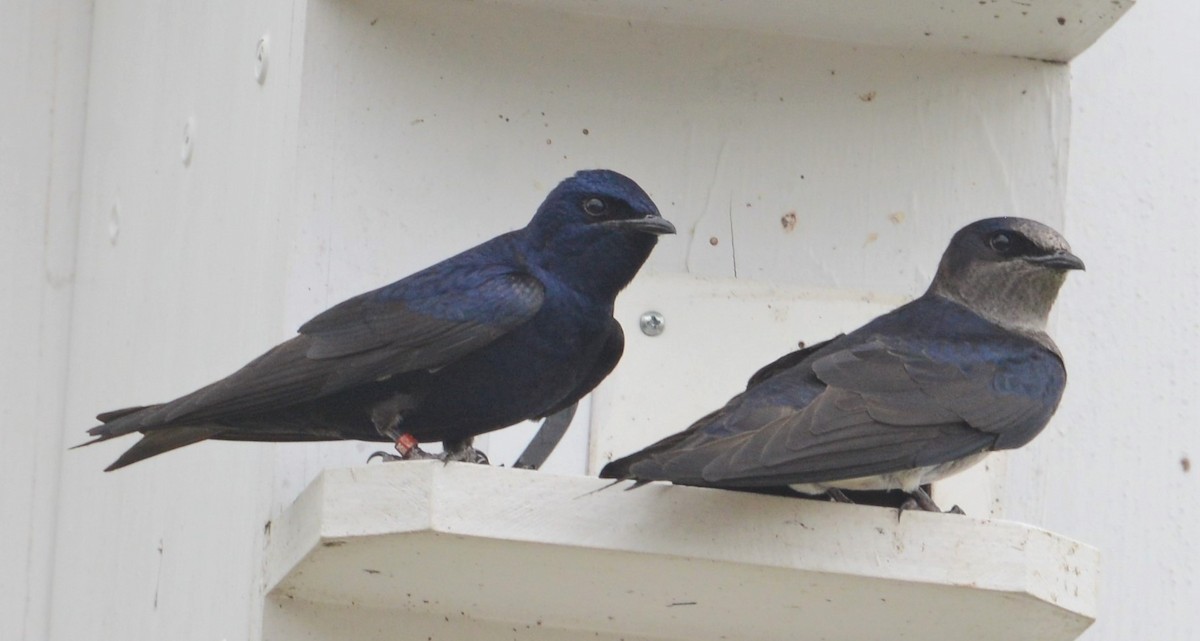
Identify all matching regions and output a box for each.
[929,217,1084,331]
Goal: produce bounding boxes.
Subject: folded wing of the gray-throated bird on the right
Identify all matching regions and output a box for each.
[622,335,1066,487]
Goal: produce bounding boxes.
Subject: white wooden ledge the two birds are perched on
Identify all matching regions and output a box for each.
[263,461,1099,641]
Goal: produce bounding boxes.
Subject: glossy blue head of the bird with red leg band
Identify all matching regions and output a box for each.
[526,169,676,296]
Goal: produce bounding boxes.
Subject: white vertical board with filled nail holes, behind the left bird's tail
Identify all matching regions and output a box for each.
[49,1,302,641]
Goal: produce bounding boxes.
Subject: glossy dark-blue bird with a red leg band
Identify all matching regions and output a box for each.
[77,169,674,469]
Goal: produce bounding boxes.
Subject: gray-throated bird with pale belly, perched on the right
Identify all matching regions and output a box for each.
[600,217,1084,510]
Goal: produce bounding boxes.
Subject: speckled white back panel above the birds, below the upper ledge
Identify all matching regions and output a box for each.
[289,0,1068,297]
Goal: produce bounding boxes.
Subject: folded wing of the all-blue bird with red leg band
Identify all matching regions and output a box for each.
[89,270,545,437]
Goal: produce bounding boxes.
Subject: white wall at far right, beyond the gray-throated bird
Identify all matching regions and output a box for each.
[1004,0,1200,641]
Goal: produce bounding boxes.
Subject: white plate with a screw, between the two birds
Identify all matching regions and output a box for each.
[588,274,904,474]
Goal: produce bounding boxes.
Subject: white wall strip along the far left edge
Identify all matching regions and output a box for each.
[0,0,91,640]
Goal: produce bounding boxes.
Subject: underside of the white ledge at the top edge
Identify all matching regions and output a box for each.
[491,0,1134,61]
